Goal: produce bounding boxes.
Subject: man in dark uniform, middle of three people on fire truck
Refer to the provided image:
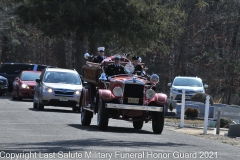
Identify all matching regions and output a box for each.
[105,56,125,79]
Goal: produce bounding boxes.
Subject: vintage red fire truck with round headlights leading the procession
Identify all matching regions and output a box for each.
[80,54,167,134]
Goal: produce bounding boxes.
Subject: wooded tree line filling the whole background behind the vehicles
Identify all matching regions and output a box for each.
[0,0,240,104]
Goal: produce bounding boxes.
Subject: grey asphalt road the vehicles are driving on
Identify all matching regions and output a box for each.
[0,96,239,160]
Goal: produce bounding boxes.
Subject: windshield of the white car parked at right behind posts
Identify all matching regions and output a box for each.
[173,78,202,87]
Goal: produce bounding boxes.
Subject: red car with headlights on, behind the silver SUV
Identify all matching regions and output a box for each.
[12,71,42,101]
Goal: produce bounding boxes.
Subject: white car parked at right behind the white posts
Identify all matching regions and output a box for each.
[168,76,208,101]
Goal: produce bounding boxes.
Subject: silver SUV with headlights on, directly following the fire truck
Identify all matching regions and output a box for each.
[33,68,82,112]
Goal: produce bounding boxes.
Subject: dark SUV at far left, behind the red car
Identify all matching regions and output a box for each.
[0,63,48,92]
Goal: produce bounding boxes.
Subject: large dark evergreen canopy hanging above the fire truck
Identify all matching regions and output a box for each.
[16,0,186,54]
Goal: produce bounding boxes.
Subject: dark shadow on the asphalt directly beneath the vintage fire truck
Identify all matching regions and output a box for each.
[68,124,156,134]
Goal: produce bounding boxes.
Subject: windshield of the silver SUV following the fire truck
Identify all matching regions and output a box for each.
[43,71,81,85]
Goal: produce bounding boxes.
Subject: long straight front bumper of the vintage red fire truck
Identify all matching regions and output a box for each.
[105,103,163,112]
